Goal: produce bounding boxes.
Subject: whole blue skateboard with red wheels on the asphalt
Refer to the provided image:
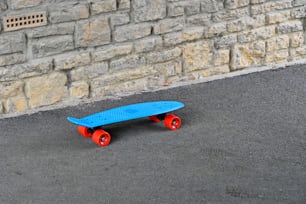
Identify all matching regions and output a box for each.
[67,101,184,147]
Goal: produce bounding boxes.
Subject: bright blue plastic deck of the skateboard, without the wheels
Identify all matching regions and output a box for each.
[67,101,184,128]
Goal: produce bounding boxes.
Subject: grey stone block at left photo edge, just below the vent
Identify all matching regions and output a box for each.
[0,32,26,55]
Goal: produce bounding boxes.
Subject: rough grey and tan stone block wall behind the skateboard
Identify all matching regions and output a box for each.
[0,0,306,114]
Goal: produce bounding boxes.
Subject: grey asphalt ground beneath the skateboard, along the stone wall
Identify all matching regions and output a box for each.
[0,65,306,204]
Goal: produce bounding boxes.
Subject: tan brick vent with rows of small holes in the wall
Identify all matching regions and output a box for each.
[3,12,47,31]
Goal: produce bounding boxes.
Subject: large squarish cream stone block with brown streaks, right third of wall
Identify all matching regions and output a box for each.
[230,41,266,71]
